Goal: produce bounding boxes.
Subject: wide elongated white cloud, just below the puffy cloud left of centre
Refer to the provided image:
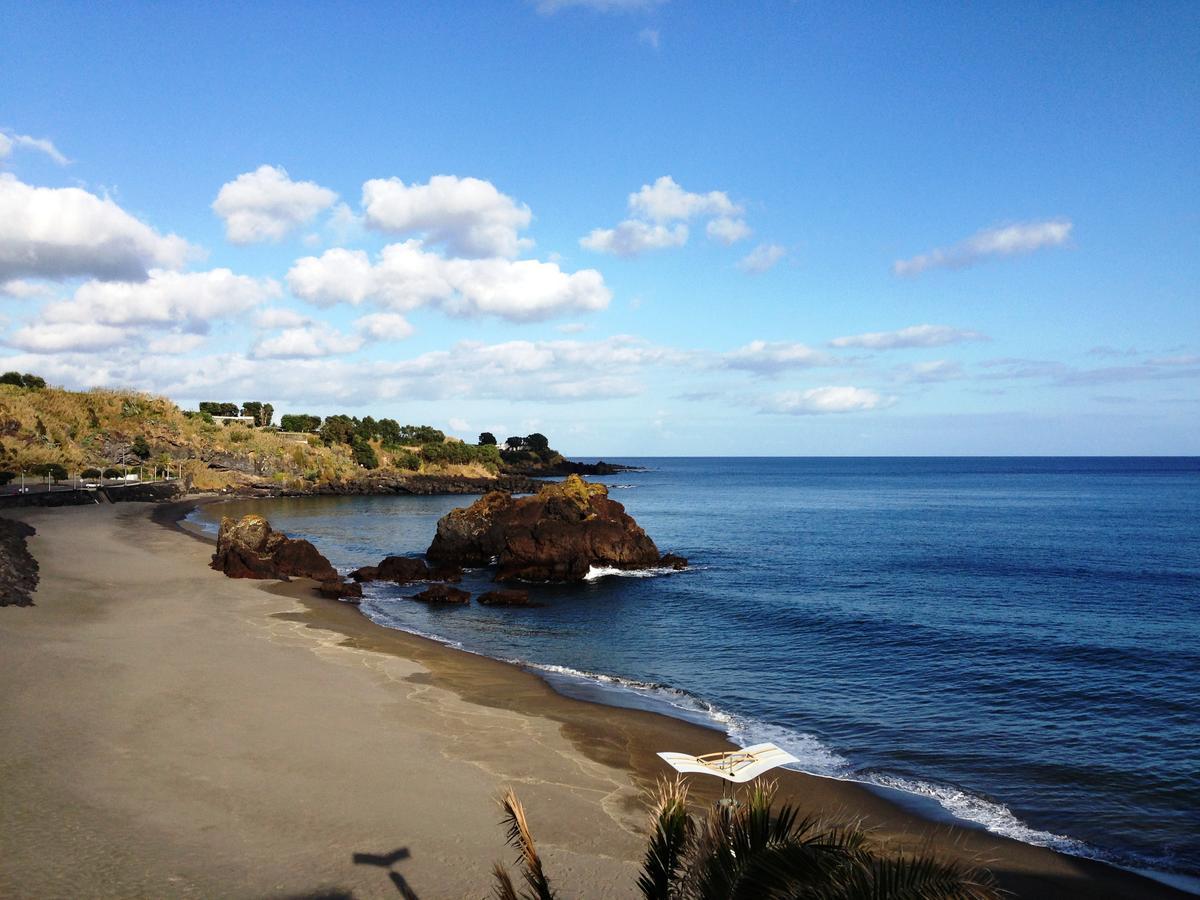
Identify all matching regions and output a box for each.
[287,240,612,322]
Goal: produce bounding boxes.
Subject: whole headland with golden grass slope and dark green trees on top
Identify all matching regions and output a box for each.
[0,372,595,492]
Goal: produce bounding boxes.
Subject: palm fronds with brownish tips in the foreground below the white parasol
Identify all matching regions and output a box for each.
[492,779,1000,900]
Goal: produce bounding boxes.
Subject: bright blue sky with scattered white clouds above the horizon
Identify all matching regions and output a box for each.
[0,0,1200,456]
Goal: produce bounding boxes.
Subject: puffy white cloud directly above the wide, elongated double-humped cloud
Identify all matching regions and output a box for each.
[362,175,533,257]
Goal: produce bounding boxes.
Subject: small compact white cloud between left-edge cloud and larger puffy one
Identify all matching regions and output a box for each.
[212,166,337,244]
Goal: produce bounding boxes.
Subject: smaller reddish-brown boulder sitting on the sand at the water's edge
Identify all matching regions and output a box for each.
[212,516,340,582]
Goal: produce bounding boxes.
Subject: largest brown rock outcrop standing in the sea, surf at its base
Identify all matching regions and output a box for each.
[425,475,686,581]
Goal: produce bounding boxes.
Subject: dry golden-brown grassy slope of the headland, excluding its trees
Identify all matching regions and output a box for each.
[0,384,493,490]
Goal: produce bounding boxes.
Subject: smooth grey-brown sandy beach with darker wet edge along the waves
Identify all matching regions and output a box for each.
[0,504,1187,899]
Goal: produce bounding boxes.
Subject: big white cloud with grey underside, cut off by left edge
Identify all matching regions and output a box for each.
[0,173,193,281]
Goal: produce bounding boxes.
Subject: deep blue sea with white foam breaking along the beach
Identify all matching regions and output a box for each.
[189,458,1200,878]
